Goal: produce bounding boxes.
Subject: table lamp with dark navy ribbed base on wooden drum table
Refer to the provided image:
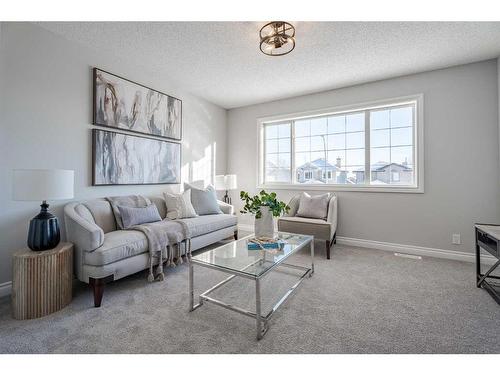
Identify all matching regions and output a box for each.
[13,169,74,251]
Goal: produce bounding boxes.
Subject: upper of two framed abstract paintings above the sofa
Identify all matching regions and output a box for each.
[93,68,182,141]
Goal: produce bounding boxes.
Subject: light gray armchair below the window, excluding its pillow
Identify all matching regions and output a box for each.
[278,194,338,259]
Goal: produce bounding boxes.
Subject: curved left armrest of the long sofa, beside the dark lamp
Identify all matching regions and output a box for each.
[64,203,104,252]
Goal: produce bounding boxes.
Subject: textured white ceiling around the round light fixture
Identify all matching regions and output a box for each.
[39,22,500,108]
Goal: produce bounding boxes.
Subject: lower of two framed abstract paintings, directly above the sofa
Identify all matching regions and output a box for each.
[92,129,181,186]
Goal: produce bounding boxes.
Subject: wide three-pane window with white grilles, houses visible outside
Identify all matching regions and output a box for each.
[259,96,423,192]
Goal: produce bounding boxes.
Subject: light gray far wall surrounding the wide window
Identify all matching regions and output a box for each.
[228,60,500,258]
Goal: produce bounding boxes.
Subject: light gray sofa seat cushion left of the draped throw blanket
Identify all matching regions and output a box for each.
[84,230,148,266]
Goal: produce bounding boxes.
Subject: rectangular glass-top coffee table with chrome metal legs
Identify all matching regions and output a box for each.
[189,232,314,340]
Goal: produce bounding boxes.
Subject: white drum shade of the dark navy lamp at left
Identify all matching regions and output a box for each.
[13,169,75,201]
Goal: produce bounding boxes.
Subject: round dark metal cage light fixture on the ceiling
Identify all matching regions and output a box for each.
[260,21,295,56]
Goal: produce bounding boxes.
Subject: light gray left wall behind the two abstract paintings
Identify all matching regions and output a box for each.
[0,23,226,284]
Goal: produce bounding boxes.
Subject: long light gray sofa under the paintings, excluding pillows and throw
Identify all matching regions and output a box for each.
[64,197,238,307]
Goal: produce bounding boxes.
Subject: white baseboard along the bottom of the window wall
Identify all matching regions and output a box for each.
[238,224,496,264]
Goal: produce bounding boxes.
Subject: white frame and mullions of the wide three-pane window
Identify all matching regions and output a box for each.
[257,94,424,193]
